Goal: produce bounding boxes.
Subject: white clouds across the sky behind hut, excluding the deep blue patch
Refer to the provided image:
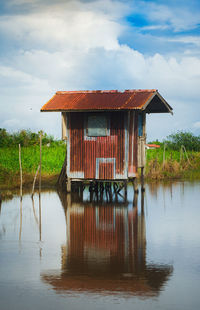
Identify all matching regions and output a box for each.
[0,0,200,138]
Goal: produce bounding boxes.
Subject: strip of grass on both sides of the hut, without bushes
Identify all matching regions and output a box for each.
[0,144,200,189]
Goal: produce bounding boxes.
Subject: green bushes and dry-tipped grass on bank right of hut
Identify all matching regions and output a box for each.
[146,131,200,179]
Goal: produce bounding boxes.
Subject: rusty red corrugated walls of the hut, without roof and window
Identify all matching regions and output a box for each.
[62,111,146,180]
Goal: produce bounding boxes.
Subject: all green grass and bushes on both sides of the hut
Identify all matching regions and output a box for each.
[0,129,200,189]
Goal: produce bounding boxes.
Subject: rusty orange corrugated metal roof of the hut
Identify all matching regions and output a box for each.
[41,89,172,112]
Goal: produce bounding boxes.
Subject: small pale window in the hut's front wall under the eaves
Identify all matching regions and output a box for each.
[86,113,109,137]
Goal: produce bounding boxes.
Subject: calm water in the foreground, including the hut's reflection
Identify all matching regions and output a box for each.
[0,182,200,310]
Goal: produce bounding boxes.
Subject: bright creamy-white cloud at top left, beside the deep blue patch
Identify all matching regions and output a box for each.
[0,1,124,51]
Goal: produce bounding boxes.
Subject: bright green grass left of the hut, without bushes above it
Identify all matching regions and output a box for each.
[0,145,66,189]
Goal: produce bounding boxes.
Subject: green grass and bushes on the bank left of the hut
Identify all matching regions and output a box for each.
[0,129,66,188]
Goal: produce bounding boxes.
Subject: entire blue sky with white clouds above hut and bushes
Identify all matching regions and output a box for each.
[0,0,200,141]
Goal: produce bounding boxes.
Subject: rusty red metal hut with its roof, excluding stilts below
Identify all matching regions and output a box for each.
[41,89,172,186]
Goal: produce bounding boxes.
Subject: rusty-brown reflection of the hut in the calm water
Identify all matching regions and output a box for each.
[42,195,173,297]
